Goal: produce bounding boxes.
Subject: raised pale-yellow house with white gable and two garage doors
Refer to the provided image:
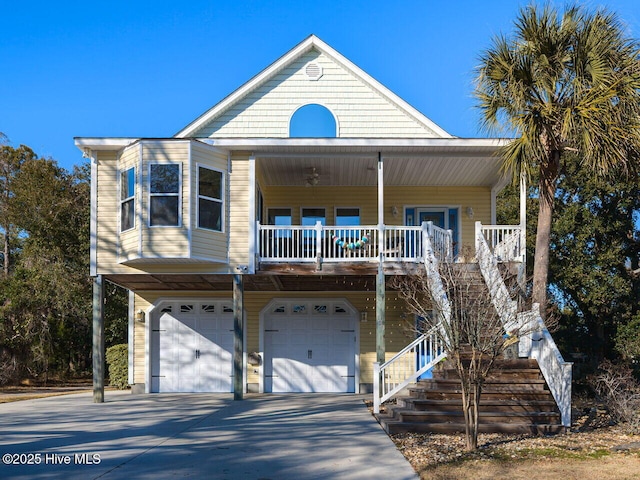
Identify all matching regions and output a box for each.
[75,36,568,430]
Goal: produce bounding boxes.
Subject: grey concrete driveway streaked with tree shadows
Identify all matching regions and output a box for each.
[0,392,417,480]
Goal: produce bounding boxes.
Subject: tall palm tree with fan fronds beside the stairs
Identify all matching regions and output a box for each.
[475,5,640,315]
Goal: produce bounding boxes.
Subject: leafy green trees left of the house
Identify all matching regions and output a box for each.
[0,155,91,381]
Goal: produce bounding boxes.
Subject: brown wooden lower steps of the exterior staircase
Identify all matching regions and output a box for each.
[378,358,564,434]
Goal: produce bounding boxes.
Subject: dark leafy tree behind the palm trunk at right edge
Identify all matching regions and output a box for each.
[549,161,640,359]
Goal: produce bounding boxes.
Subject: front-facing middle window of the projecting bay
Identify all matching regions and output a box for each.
[149,163,181,227]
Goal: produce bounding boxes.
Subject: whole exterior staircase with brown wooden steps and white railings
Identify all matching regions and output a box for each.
[373,222,572,434]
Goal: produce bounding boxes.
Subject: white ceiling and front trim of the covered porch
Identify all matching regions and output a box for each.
[230,139,510,187]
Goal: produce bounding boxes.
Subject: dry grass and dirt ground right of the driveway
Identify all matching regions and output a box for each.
[391,426,640,480]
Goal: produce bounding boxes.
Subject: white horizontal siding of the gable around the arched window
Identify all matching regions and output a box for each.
[190,50,439,138]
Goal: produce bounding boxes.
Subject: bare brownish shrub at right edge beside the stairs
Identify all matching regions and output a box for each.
[592,360,640,434]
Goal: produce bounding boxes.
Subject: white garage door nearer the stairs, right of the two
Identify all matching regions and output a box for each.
[264,300,357,393]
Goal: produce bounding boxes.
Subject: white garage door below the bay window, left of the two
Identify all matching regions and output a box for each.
[151,301,233,392]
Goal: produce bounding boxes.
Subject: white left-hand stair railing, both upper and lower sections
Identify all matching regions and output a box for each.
[373,222,452,413]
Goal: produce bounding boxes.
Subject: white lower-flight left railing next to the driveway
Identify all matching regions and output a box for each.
[373,327,446,413]
